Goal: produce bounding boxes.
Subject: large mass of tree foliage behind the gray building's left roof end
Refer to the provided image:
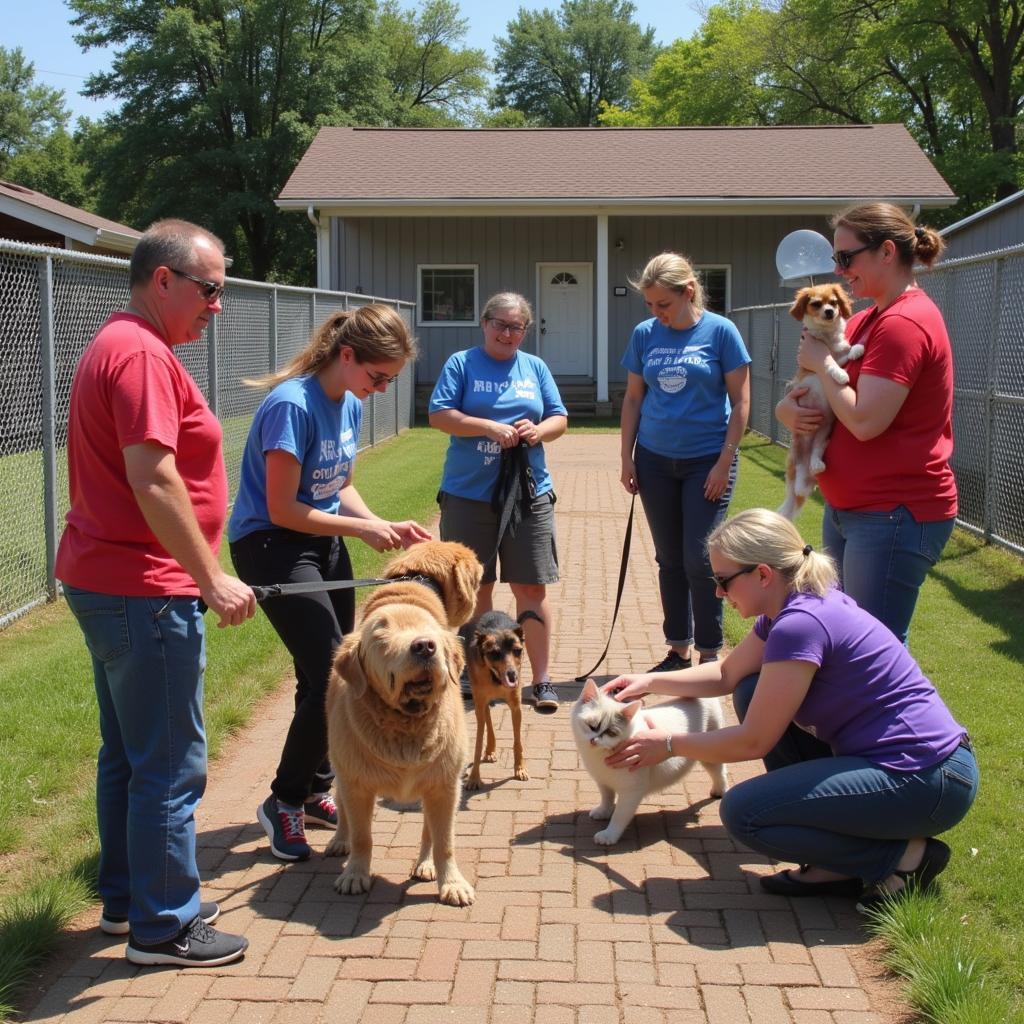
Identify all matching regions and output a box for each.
[70,0,482,281]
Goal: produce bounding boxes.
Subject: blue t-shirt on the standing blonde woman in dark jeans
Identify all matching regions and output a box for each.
[622,310,751,459]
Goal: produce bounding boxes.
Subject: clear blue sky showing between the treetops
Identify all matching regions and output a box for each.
[9,0,700,118]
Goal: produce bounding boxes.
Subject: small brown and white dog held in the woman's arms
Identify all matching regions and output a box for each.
[778,285,864,519]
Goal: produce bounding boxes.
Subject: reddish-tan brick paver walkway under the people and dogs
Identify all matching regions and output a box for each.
[26,435,894,1024]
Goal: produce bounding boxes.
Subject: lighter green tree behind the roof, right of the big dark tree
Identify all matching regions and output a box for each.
[378,0,488,126]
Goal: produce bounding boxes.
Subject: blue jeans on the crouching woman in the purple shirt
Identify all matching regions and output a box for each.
[721,675,978,883]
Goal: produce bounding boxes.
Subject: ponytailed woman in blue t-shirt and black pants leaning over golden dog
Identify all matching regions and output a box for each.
[227,304,430,860]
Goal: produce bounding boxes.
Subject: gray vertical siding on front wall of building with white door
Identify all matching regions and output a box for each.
[330,210,828,387]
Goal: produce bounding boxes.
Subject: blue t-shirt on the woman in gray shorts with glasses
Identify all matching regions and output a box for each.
[430,347,566,502]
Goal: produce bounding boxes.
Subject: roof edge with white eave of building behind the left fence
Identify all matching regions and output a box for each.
[0,181,142,253]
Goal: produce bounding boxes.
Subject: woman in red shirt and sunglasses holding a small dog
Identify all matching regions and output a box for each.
[775,203,956,643]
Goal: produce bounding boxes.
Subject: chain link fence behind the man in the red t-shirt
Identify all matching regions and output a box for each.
[0,240,415,629]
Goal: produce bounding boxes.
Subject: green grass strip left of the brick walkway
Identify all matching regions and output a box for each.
[0,427,446,1019]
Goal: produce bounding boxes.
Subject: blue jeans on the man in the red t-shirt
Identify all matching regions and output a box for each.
[65,586,206,944]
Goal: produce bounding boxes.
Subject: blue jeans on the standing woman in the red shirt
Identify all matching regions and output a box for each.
[821,504,953,644]
